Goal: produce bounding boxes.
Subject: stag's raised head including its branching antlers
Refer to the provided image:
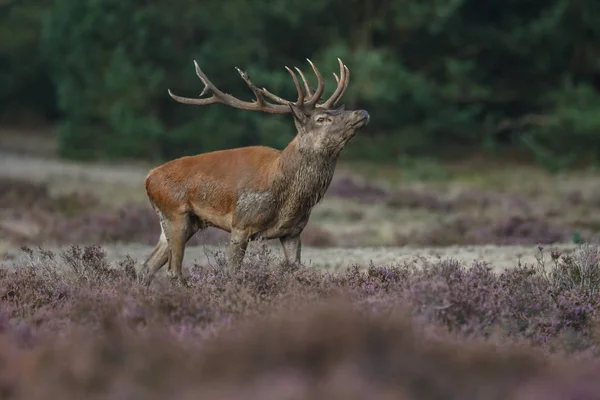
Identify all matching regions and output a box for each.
[169,58,370,157]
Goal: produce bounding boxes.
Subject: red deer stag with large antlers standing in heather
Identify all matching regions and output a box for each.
[143,58,370,285]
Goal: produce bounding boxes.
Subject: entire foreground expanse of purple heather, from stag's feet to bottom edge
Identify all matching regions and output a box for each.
[0,244,600,399]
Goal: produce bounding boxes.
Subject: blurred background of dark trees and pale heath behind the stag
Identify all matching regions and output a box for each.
[0,0,600,255]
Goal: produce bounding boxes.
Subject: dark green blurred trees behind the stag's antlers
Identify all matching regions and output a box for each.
[0,0,600,166]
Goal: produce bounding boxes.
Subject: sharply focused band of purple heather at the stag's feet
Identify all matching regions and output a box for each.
[2,242,598,345]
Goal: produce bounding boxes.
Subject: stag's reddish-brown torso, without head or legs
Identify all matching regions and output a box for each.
[146,143,335,239]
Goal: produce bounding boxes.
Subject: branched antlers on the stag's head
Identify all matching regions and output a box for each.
[168,58,350,114]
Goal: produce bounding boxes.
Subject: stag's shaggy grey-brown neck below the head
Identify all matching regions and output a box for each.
[273,137,337,212]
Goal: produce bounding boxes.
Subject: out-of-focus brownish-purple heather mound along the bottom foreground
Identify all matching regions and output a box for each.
[0,302,546,400]
